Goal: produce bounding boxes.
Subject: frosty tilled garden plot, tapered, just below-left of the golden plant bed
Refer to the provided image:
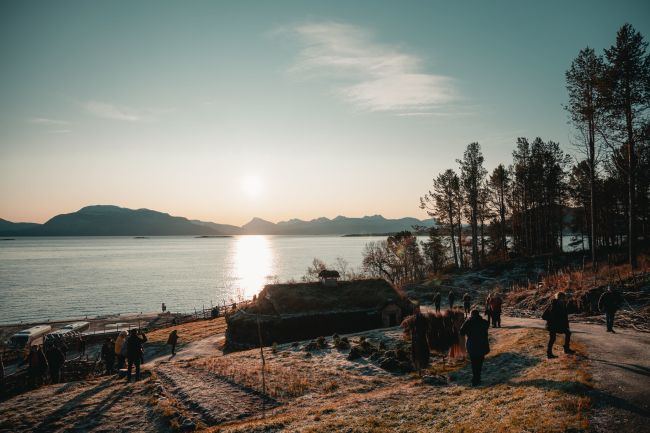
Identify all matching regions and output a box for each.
[155,363,278,426]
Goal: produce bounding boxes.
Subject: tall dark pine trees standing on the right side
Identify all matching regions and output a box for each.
[412,24,650,271]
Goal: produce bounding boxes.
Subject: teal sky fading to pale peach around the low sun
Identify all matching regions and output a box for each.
[0,0,650,225]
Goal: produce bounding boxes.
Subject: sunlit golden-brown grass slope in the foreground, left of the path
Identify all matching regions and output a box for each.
[199,328,592,433]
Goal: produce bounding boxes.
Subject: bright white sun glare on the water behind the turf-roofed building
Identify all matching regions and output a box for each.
[234,235,273,299]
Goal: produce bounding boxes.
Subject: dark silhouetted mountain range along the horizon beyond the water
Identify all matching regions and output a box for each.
[0,205,435,237]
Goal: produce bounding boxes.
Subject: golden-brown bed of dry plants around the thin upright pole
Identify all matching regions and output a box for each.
[194,357,312,401]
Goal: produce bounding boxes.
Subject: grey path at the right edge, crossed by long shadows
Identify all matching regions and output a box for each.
[503,317,650,433]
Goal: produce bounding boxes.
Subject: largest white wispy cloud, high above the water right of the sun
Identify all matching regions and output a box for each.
[281,22,457,116]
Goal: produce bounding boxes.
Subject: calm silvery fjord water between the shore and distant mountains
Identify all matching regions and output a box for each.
[0,236,382,323]
